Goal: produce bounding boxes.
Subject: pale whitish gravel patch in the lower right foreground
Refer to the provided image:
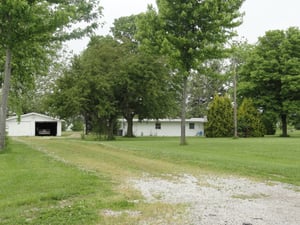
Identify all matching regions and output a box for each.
[130,174,300,225]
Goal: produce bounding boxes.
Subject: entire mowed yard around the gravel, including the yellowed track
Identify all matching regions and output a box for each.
[0,135,300,224]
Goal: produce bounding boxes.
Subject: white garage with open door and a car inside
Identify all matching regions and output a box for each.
[6,112,61,136]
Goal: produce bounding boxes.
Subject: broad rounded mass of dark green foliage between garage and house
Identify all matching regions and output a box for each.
[48,33,174,139]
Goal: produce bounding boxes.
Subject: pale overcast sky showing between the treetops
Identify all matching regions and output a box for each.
[68,0,300,53]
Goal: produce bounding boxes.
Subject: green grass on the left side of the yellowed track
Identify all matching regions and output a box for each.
[0,142,132,225]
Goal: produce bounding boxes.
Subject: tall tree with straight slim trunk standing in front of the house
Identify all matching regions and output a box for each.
[139,0,244,145]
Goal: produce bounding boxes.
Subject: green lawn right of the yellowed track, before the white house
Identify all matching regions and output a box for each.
[109,135,300,185]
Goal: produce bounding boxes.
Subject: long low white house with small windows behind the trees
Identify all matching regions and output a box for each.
[121,118,206,137]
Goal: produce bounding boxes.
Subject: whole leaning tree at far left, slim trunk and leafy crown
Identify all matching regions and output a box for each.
[0,0,99,150]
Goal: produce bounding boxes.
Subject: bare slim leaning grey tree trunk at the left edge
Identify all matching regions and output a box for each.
[0,48,12,151]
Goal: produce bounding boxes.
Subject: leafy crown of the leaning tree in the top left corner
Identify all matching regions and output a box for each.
[0,0,99,48]
